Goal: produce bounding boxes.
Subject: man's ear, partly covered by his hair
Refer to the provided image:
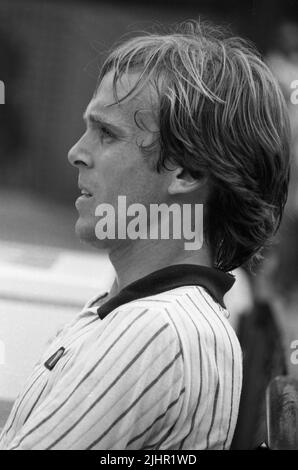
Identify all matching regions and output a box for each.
[168,167,207,195]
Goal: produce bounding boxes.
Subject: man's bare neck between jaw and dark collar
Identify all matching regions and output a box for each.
[109,240,211,295]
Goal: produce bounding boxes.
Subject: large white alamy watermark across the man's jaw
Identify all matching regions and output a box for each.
[95,196,203,250]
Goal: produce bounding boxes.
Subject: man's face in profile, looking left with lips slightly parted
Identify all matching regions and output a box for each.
[68,72,170,247]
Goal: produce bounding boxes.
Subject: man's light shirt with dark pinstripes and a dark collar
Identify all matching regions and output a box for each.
[0,265,242,450]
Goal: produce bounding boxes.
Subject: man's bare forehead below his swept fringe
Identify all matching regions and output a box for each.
[86,71,157,124]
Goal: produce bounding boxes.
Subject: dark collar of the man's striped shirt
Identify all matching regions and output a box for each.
[97,264,235,319]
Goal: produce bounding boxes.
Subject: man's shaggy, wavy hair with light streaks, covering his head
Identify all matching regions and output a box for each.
[98,21,290,271]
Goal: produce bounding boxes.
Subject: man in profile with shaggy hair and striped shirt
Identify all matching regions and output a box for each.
[1,22,289,450]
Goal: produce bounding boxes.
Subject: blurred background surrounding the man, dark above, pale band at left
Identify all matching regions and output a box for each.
[0,0,298,448]
